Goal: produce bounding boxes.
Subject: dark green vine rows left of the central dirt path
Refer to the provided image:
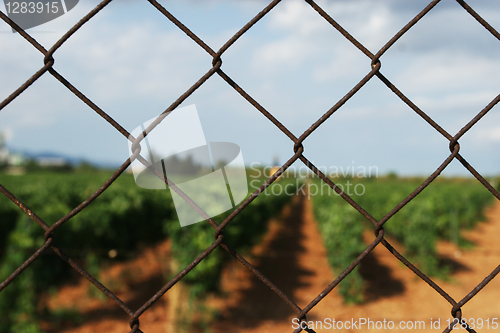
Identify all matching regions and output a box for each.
[0,172,296,333]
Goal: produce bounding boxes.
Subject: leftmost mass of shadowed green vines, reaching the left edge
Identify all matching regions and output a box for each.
[0,172,175,333]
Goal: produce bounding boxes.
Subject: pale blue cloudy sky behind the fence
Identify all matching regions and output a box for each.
[0,0,500,175]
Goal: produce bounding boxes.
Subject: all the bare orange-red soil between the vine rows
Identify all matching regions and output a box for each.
[44,197,500,333]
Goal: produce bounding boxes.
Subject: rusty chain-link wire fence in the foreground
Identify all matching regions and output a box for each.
[0,0,500,332]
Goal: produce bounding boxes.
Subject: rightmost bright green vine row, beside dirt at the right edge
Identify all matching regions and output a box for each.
[356,179,493,278]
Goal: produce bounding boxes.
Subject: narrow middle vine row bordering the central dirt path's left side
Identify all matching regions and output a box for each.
[165,177,296,332]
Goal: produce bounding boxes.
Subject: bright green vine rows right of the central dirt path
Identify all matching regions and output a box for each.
[313,177,493,303]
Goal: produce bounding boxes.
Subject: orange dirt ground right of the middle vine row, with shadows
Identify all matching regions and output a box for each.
[212,198,500,333]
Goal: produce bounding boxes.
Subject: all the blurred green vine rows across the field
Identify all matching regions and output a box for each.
[0,171,493,333]
